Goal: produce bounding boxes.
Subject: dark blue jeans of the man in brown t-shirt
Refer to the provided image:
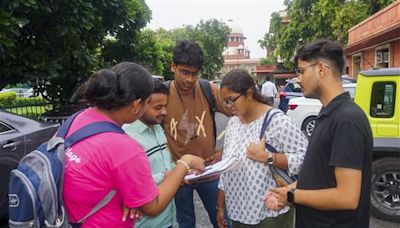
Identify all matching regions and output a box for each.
[175,179,218,228]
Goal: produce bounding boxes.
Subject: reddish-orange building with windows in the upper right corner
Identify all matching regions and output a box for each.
[345,1,400,78]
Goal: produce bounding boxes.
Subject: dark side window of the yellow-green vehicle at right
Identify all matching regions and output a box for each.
[370,82,396,118]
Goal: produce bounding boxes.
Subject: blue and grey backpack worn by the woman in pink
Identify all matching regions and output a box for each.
[8,112,124,227]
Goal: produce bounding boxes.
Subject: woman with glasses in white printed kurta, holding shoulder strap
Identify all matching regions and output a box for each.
[217,69,307,228]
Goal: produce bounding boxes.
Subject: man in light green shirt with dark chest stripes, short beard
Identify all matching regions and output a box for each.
[122,79,176,228]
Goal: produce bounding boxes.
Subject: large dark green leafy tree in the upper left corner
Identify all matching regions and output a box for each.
[0,0,150,101]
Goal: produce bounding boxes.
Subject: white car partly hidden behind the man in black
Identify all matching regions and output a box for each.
[287,83,356,137]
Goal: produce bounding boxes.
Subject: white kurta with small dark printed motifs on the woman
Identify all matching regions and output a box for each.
[218,109,308,224]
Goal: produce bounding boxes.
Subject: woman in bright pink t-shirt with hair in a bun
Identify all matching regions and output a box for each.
[63,62,204,227]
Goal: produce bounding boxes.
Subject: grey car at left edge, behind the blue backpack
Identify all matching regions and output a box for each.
[0,110,59,219]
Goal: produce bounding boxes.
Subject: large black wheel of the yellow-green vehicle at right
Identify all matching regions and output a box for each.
[371,157,400,222]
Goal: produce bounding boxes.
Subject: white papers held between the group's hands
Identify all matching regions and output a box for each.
[185,157,240,181]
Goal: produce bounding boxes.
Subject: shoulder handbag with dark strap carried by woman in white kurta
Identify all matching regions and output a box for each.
[260,109,296,187]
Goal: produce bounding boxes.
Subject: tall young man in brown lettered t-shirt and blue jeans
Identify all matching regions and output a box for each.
[164,40,229,228]
